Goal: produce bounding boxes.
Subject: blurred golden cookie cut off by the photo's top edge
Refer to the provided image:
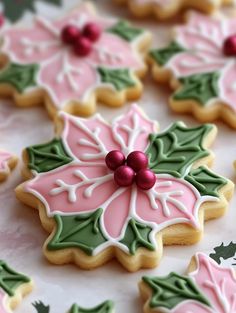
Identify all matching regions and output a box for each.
[115,0,230,19]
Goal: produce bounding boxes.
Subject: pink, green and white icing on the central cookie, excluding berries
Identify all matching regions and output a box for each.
[20,105,227,264]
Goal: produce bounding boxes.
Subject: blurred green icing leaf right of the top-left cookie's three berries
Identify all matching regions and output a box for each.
[107,21,143,42]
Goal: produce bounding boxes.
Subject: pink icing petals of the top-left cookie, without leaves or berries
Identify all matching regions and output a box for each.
[2,5,145,108]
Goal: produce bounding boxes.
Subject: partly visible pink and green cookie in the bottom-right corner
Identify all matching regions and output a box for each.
[140,253,236,313]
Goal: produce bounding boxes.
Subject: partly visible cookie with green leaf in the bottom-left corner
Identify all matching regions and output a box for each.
[0,260,33,313]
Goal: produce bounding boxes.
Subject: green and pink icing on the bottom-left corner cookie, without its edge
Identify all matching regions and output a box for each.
[0,260,31,313]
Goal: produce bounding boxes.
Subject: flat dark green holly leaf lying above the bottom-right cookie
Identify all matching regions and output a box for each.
[210,241,236,265]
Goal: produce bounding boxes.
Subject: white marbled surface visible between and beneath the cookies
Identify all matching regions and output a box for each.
[0,0,236,313]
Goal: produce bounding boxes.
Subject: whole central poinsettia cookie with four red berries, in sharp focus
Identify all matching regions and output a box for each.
[16,105,233,271]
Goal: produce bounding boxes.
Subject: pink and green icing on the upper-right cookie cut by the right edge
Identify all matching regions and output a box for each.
[151,13,236,112]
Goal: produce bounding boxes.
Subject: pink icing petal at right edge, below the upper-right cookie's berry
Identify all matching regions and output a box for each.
[219,61,236,111]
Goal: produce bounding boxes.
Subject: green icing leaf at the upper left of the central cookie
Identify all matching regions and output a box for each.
[27,138,73,173]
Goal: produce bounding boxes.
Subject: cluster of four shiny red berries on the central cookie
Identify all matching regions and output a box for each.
[105,150,156,190]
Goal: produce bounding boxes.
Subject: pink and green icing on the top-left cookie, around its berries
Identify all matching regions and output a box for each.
[0,4,147,113]
